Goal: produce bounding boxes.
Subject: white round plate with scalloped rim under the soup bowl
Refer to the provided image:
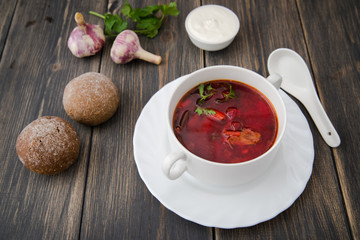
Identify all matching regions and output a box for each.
[133,77,314,228]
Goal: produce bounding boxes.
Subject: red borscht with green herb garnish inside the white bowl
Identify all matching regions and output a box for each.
[173,80,278,163]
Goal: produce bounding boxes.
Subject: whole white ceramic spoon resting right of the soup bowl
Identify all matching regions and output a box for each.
[267,48,340,147]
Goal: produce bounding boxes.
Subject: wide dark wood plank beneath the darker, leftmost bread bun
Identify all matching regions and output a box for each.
[0,1,105,239]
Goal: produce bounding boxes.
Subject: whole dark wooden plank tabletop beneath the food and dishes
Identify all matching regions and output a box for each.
[0,0,360,239]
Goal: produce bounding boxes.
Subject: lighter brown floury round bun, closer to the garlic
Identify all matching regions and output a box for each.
[63,72,120,126]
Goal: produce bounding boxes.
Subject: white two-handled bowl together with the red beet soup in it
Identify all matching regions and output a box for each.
[162,65,286,186]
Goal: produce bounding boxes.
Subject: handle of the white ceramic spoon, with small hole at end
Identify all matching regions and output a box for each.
[303,93,341,147]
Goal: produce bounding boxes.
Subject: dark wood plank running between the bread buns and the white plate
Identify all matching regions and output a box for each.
[81,1,212,239]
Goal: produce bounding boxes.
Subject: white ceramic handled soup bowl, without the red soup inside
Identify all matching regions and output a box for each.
[162,65,287,186]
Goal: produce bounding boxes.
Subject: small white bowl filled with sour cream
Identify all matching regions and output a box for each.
[185,4,240,51]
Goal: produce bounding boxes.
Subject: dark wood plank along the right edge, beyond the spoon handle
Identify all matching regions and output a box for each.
[298,0,360,239]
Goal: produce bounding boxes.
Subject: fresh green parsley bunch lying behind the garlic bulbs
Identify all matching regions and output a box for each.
[89,1,180,38]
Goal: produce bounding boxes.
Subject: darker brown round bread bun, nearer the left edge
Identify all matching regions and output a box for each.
[16,116,80,175]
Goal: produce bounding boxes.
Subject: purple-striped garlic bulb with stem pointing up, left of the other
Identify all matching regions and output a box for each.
[67,13,105,58]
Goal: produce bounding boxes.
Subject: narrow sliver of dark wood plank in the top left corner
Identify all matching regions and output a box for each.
[0,1,17,57]
